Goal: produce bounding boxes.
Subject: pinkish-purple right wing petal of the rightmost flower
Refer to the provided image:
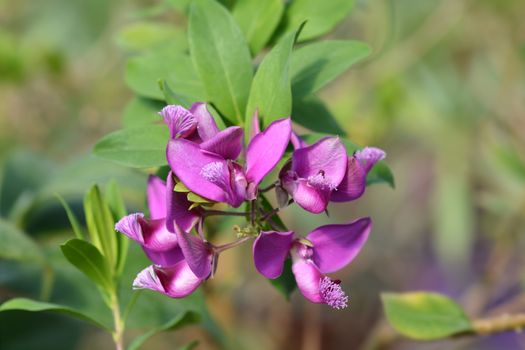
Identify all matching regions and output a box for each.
[330,157,366,202]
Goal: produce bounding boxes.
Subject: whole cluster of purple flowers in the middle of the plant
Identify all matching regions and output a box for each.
[116,103,385,309]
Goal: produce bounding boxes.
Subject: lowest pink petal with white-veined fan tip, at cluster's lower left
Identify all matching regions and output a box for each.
[133,260,202,298]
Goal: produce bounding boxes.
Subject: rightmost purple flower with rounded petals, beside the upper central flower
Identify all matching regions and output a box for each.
[279,135,385,214]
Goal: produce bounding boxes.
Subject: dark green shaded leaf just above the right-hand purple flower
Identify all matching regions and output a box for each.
[292,95,345,136]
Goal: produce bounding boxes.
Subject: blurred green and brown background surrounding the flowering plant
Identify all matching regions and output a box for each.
[0,0,525,350]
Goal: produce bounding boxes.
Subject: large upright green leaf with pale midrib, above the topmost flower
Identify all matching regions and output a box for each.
[188,0,253,124]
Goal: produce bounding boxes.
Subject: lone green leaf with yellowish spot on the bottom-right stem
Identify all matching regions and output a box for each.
[381,292,472,340]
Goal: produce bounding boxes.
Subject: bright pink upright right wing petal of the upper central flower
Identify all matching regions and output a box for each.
[246,118,292,185]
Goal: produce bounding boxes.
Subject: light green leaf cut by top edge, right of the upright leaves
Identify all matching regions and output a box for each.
[284,0,354,41]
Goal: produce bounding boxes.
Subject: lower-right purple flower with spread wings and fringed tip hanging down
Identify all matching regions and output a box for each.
[253,218,372,309]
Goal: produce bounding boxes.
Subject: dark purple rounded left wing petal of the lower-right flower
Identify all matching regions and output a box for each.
[253,231,293,279]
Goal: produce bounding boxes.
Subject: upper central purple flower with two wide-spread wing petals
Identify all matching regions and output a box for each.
[166,118,291,208]
